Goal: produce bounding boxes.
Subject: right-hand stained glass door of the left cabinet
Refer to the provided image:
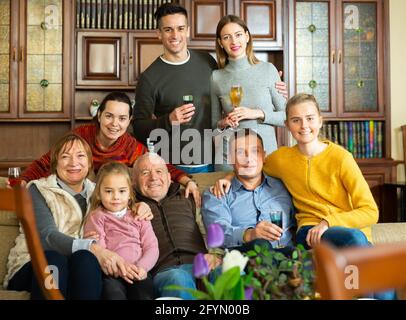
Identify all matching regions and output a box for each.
[19,0,73,118]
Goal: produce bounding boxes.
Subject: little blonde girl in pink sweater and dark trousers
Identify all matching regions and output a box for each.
[84,162,159,300]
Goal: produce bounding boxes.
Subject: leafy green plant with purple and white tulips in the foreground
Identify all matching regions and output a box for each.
[168,224,315,300]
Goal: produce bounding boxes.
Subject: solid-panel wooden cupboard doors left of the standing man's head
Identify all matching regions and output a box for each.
[76,30,163,89]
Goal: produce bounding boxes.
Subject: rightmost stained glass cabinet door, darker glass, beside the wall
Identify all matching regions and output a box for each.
[338,1,384,117]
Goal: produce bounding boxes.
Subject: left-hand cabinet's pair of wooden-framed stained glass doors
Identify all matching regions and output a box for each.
[0,0,72,119]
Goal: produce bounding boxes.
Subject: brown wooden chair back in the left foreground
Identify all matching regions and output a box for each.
[0,186,64,300]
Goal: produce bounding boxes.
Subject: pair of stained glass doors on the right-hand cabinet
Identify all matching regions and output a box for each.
[295,0,384,118]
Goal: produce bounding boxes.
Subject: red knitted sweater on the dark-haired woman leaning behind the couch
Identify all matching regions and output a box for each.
[22,124,186,182]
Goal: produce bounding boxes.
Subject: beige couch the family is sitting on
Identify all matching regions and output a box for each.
[0,172,406,300]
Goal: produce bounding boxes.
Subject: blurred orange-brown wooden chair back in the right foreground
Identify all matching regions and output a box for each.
[314,242,406,300]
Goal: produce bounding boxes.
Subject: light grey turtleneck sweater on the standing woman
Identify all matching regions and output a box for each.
[211,58,286,153]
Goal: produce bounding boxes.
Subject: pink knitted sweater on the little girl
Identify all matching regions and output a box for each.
[84,207,159,272]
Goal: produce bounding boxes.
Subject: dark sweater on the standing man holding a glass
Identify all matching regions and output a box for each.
[133,50,217,164]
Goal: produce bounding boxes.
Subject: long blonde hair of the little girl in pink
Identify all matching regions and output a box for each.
[89,161,135,212]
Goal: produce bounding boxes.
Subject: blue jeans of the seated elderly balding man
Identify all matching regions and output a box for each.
[154,264,196,300]
